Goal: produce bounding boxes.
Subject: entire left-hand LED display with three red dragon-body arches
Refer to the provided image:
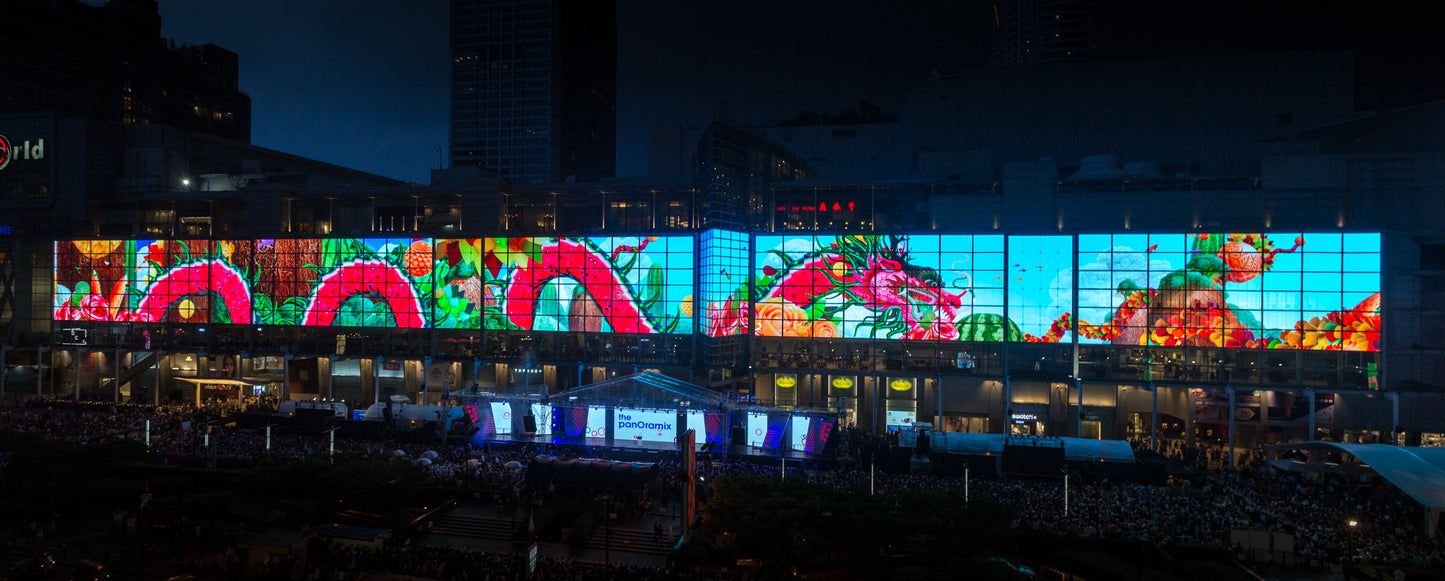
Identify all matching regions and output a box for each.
[53,237,694,334]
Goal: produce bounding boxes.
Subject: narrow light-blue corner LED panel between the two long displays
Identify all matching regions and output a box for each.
[699,230,751,337]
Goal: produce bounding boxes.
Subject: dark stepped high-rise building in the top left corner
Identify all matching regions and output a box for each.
[0,0,251,143]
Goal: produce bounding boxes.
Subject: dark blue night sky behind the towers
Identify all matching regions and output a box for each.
[160,0,1445,182]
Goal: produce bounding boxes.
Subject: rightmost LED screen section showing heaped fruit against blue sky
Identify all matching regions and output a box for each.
[1077,233,1381,351]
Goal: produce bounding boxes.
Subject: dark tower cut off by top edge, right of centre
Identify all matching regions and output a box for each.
[988,0,1100,66]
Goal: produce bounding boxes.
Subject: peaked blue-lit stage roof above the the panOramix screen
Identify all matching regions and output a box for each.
[548,371,727,409]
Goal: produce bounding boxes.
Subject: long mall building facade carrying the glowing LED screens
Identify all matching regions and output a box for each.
[4,106,1445,445]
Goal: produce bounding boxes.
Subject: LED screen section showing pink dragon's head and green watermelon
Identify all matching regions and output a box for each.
[753,234,1017,341]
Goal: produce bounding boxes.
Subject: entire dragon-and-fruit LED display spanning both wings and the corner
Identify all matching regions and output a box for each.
[53,230,1381,351]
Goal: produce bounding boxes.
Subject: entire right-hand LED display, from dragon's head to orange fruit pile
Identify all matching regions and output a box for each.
[751,233,1381,351]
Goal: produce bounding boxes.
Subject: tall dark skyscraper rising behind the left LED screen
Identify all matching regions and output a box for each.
[451,0,617,184]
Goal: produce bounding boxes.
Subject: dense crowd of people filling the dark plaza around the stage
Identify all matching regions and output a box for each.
[0,402,1445,578]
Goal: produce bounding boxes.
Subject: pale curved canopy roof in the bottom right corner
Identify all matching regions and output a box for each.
[1269,441,1445,536]
